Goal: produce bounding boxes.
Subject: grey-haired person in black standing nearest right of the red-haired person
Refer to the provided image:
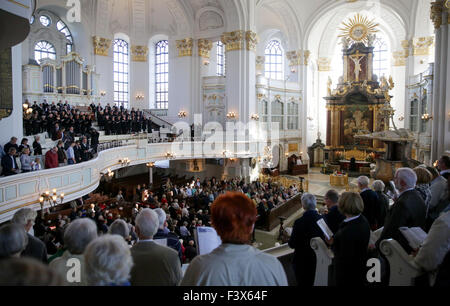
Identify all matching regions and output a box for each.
[288,193,323,287]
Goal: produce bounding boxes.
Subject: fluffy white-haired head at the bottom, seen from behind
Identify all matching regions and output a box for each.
[84,235,133,286]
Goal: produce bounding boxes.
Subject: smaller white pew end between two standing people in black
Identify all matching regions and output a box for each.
[310,237,334,286]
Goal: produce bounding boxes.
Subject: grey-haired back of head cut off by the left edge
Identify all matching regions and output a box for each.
[0,223,28,260]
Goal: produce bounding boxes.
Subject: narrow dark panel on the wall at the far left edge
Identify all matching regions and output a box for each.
[0,48,13,120]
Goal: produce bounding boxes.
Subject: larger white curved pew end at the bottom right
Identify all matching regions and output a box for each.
[380,239,424,286]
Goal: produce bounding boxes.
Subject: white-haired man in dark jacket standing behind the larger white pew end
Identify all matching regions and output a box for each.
[377,168,426,254]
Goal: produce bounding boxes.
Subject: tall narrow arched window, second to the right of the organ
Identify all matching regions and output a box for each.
[155,40,169,109]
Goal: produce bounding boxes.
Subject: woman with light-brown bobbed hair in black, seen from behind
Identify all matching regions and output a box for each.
[328,192,370,287]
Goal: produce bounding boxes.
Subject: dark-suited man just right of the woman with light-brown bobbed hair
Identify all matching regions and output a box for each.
[358,176,383,231]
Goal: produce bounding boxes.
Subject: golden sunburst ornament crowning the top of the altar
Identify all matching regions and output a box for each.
[339,14,379,43]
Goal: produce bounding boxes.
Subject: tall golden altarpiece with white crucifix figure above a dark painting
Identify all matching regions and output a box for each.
[324,15,394,162]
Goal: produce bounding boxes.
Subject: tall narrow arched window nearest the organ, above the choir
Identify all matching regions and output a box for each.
[113,39,129,108]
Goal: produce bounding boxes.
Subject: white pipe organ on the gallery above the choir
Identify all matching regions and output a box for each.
[23,52,100,105]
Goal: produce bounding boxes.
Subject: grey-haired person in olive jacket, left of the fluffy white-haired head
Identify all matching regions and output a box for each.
[50,218,97,286]
